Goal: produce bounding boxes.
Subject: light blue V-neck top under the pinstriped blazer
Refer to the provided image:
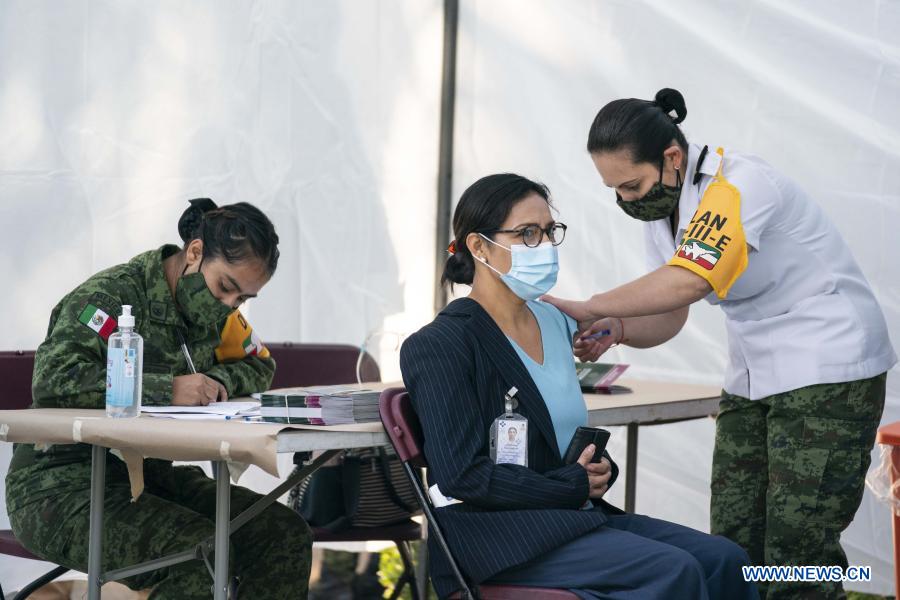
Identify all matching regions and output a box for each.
[507,300,587,456]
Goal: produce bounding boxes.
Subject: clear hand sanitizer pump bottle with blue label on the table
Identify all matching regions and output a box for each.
[106,304,144,417]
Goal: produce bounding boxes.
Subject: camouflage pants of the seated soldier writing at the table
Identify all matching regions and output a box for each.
[9,461,312,600]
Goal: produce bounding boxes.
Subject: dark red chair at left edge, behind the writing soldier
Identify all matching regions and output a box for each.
[0,350,69,600]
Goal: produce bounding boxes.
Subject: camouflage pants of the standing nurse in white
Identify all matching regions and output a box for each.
[710,374,886,600]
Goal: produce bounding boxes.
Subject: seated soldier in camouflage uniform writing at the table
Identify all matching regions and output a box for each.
[6,200,312,600]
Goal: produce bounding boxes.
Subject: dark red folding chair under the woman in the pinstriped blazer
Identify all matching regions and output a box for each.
[378,388,578,600]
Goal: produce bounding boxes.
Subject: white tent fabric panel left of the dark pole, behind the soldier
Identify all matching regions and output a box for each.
[0,0,442,590]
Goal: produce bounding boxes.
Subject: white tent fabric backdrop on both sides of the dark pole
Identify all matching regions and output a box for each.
[0,0,900,593]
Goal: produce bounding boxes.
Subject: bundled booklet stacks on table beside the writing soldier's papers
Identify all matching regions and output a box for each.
[259,385,380,425]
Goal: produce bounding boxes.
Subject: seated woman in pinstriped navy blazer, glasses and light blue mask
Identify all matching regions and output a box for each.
[400,174,758,600]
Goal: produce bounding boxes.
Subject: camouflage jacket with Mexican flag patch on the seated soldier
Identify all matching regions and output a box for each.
[10,245,275,502]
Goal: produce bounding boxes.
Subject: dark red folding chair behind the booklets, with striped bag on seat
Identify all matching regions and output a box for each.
[266,342,422,600]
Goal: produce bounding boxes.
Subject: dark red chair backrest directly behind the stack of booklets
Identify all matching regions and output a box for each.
[266,342,381,388]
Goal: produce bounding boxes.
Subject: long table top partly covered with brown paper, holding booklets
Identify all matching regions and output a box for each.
[0,379,719,468]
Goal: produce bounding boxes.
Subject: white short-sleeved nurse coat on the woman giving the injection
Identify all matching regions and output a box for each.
[645,144,897,400]
